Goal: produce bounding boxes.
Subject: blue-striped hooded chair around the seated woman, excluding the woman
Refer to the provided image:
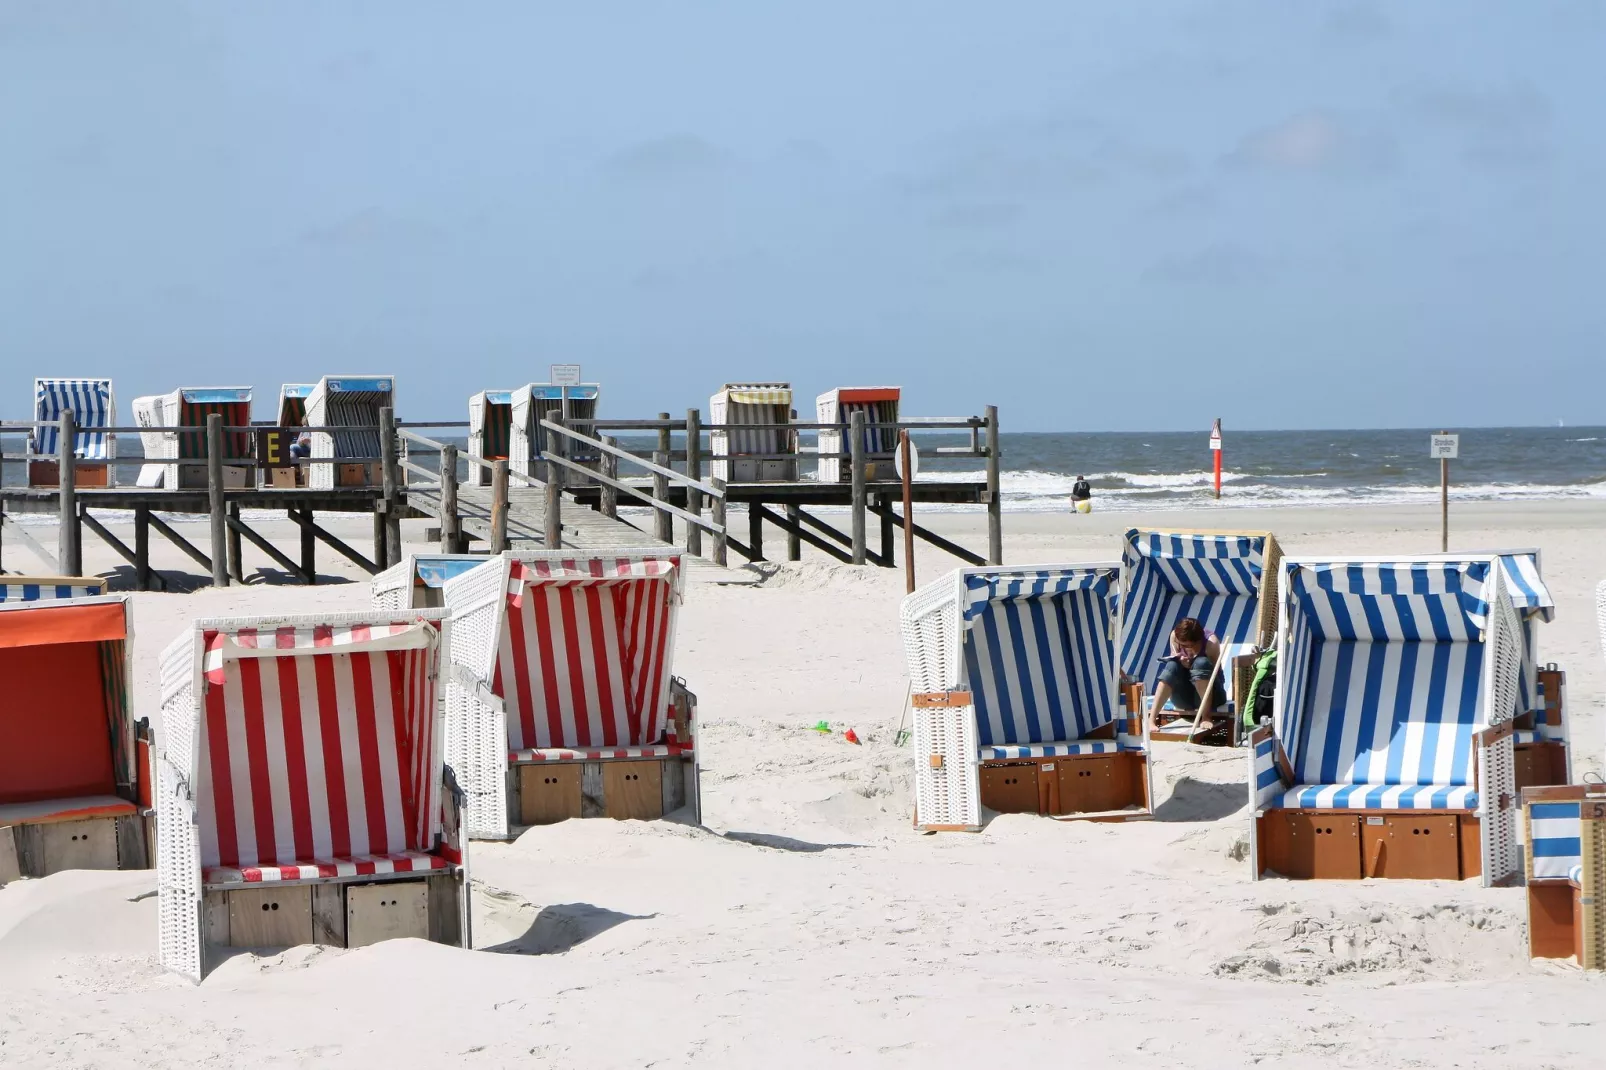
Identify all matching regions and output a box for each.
[1119,529,1282,741]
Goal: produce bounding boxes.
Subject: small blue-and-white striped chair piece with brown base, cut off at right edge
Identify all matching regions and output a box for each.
[1522,784,1606,970]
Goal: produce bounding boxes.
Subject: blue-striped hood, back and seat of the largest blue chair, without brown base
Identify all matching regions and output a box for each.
[1272,559,1521,810]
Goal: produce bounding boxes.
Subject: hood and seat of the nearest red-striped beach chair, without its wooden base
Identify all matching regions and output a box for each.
[162,611,448,887]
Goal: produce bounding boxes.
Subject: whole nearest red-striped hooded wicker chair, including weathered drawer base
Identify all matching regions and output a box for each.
[156,609,469,980]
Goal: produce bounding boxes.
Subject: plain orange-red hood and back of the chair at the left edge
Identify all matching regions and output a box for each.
[0,596,137,824]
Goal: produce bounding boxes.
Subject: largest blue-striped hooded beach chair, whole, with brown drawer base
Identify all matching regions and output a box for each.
[1249,556,1522,885]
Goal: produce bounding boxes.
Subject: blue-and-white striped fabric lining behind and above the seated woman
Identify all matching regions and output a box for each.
[1121,529,1266,691]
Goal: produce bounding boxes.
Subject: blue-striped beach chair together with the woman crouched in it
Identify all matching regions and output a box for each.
[1119,529,1282,744]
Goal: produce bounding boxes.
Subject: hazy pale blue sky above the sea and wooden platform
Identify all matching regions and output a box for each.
[0,0,1606,431]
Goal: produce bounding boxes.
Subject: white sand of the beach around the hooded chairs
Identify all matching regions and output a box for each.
[0,503,1606,1068]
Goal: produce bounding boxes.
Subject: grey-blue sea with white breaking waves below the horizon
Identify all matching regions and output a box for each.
[5,427,1606,522]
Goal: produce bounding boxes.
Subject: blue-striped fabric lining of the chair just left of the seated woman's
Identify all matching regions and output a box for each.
[964,569,1119,749]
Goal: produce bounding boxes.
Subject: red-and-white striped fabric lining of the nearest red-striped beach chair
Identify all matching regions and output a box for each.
[196,627,440,868]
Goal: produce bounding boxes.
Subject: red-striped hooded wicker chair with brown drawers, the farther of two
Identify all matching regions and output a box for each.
[445,549,702,839]
